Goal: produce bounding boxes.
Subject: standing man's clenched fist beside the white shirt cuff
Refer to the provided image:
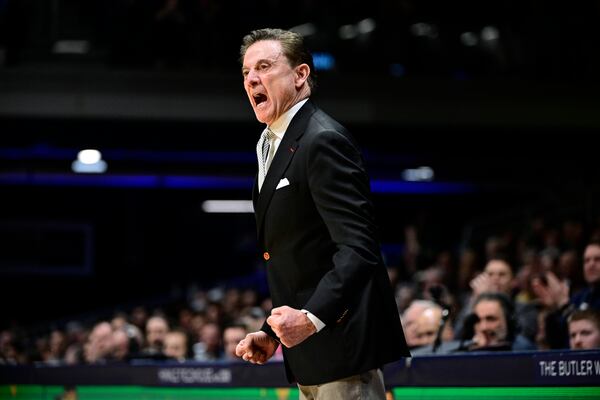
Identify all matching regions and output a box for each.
[267,306,317,348]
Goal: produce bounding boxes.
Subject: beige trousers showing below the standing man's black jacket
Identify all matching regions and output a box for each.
[298,369,385,400]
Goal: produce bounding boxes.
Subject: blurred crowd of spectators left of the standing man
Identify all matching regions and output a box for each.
[0,287,270,365]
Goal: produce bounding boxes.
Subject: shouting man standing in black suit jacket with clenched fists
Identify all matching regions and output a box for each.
[236,29,410,399]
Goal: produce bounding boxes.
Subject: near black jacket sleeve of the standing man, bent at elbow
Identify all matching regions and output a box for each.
[304,131,381,325]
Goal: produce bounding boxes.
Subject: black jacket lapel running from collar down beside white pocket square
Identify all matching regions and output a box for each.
[254,100,314,236]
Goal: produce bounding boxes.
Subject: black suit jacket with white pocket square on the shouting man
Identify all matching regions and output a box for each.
[253,100,410,385]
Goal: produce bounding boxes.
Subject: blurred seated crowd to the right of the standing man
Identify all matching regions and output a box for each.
[394,214,600,354]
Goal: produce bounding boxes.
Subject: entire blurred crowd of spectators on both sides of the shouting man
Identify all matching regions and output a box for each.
[0,212,600,365]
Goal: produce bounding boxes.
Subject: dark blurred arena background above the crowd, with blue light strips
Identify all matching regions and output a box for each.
[0,0,600,338]
